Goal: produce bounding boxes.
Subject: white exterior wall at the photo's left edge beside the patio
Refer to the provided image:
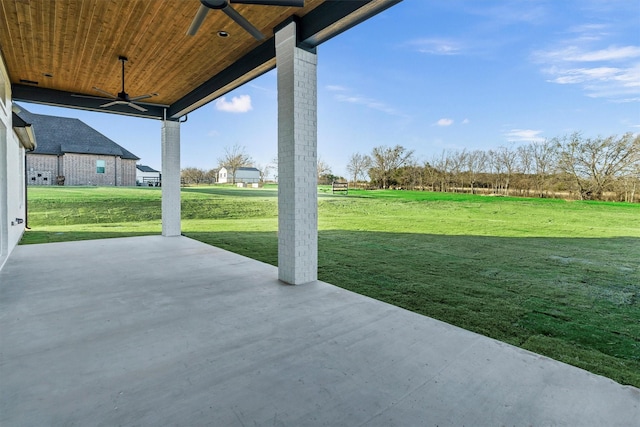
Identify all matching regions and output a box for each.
[0,55,26,268]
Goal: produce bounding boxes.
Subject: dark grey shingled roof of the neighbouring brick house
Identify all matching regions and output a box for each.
[18,106,140,160]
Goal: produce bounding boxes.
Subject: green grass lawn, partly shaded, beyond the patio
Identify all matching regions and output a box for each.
[22,187,640,387]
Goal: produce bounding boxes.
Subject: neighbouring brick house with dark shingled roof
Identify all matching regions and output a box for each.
[20,108,139,186]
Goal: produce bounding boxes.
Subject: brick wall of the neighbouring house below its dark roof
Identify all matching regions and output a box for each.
[27,153,136,187]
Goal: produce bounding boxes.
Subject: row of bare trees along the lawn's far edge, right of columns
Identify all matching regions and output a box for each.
[347,133,640,202]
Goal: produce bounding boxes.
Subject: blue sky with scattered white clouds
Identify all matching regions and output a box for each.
[25,0,640,175]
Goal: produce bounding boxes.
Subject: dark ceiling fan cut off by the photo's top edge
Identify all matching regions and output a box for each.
[187,0,304,41]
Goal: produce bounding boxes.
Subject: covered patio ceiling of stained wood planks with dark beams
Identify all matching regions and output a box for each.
[0,0,401,120]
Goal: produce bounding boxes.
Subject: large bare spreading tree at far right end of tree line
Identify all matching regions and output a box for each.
[555,133,640,200]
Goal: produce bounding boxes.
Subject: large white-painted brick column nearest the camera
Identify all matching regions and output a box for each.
[276,22,318,285]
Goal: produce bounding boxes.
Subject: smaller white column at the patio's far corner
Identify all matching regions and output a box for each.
[162,120,181,237]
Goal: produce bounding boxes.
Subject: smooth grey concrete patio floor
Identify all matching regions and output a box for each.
[0,236,640,426]
